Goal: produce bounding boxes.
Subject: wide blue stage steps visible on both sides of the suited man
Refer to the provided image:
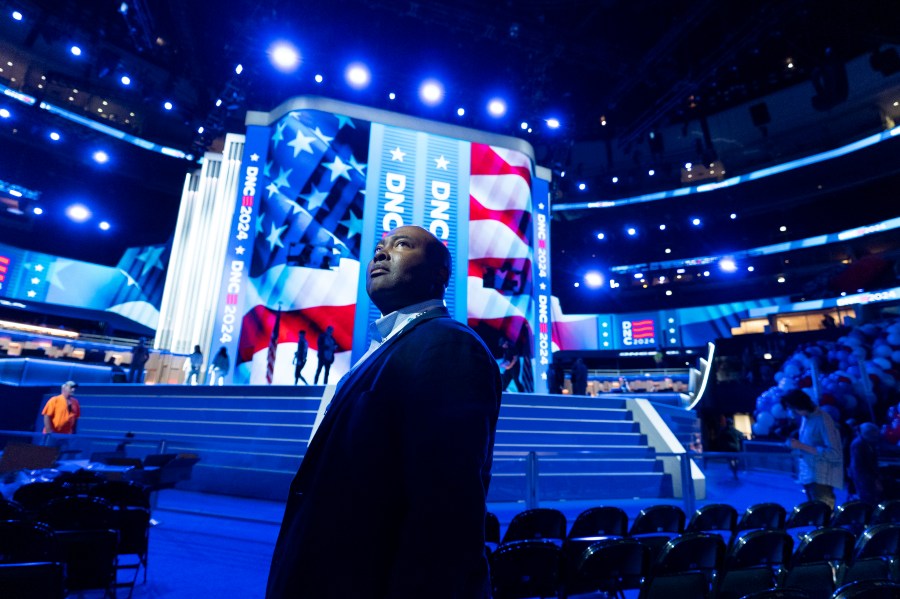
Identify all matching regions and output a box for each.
[56,384,684,501]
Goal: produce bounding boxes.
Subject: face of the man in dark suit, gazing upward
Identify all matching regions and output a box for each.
[366,227,441,314]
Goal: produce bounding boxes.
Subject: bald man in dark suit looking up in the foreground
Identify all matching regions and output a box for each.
[266,227,500,599]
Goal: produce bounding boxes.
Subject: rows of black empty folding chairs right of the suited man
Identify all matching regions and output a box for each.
[488,501,900,599]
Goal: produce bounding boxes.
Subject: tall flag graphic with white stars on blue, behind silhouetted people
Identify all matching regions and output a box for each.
[235,110,369,384]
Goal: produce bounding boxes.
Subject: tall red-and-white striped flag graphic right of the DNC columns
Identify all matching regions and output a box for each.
[467,143,534,390]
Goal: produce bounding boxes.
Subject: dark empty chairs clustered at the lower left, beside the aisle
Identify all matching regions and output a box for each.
[0,474,151,598]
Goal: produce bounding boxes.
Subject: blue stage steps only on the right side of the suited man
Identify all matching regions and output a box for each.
[488,393,673,501]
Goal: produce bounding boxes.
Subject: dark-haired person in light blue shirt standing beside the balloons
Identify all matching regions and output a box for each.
[781,389,844,509]
